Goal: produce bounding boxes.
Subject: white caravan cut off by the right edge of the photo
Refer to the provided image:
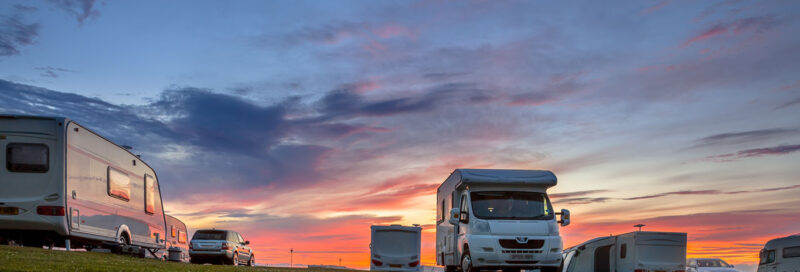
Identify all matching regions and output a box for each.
[758,234,800,272]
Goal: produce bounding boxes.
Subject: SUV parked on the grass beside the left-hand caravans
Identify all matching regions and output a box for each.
[189,229,256,266]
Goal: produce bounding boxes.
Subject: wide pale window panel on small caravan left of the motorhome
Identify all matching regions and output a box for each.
[372,230,419,256]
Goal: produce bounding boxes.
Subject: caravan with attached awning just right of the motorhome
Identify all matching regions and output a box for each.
[563,231,686,272]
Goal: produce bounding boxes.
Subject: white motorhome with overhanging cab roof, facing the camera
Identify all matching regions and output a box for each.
[436,169,569,272]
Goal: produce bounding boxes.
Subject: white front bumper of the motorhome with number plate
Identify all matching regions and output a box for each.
[467,235,562,268]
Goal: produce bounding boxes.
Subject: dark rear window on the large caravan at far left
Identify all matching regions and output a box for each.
[6,143,50,173]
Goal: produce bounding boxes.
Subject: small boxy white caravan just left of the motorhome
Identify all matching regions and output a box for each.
[369,225,422,271]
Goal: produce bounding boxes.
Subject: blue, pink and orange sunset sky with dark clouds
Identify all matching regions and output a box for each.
[0,0,800,268]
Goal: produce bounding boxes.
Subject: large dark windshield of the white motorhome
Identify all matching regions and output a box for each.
[470,191,553,220]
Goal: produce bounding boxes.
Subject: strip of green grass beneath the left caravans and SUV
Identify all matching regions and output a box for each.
[0,246,348,272]
